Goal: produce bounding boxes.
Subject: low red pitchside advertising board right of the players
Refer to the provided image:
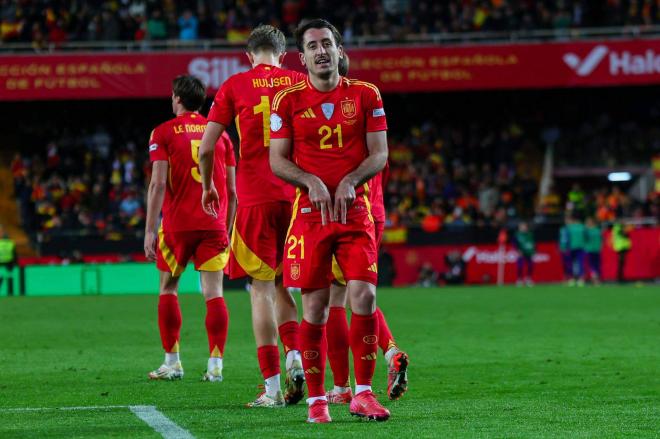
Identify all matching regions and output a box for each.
[387,228,660,285]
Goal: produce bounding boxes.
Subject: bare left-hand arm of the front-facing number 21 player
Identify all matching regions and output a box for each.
[269,138,332,225]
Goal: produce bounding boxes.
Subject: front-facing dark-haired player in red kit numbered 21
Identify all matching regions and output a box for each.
[270,19,390,423]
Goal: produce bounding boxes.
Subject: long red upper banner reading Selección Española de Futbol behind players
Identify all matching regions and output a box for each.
[0,39,660,100]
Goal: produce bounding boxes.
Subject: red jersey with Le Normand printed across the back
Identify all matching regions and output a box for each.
[149,112,236,233]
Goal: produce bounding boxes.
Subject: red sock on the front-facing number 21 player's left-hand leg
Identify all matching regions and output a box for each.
[300,319,326,398]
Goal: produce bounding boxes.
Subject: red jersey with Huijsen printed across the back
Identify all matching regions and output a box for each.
[208,64,305,206]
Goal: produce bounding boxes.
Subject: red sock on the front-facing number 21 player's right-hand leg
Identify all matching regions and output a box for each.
[350,313,378,386]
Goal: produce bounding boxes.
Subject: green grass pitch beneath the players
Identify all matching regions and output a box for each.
[0,286,660,438]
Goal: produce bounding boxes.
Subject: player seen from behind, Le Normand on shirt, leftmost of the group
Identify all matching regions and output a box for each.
[144,76,236,381]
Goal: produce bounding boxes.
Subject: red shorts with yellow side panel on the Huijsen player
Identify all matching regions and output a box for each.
[227,201,291,281]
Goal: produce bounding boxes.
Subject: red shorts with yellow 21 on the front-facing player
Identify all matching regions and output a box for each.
[284,214,378,289]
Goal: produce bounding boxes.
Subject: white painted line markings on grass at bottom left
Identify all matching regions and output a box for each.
[0,405,195,439]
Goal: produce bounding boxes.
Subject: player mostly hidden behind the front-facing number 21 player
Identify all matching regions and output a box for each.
[326,53,409,404]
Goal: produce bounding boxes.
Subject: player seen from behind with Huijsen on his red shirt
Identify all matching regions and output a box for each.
[200,25,305,407]
